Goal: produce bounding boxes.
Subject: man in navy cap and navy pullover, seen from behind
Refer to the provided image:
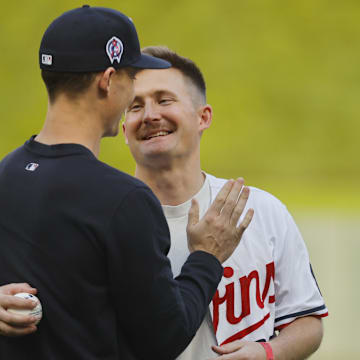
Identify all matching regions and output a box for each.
[0,6,252,360]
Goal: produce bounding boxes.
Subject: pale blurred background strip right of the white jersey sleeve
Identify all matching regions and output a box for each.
[294,210,360,360]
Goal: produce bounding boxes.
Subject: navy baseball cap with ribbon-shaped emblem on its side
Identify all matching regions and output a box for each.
[39,5,171,72]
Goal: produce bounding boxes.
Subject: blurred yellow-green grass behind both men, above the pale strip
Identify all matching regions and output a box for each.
[0,0,360,191]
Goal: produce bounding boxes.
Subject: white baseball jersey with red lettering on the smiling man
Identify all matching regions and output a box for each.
[163,174,328,360]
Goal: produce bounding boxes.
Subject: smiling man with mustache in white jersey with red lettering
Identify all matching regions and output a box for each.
[123,47,327,360]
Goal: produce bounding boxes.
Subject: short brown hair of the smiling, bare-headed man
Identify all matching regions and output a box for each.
[141,46,206,104]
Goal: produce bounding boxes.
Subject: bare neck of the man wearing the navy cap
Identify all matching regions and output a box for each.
[35,99,102,157]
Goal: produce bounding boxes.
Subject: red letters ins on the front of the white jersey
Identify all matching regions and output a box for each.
[213,262,275,333]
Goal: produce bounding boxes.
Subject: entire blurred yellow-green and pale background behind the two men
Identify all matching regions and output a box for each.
[0,0,360,360]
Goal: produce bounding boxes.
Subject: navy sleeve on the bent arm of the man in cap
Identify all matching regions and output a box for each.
[107,188,223,359]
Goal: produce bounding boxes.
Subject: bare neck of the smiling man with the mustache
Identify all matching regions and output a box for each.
[135,163,205,206]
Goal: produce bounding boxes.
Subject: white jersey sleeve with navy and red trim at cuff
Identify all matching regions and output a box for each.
[274,204,328,330]
